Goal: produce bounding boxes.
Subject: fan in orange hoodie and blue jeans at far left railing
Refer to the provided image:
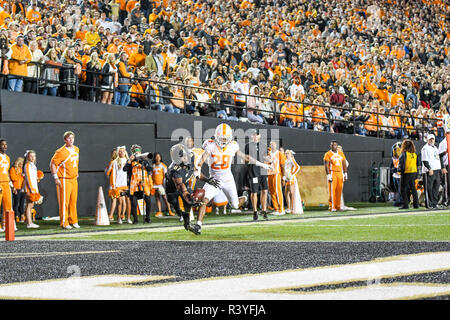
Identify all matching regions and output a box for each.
[8,35,31,92]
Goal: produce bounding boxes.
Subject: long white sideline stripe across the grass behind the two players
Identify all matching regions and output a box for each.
[12,210,450,240]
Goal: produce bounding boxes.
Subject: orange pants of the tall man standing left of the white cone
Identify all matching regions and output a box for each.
[56,178,78,227]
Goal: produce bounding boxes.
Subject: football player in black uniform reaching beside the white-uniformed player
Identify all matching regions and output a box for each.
[166,143,219,231]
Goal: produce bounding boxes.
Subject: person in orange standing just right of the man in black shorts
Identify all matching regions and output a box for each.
[267,141,286,215]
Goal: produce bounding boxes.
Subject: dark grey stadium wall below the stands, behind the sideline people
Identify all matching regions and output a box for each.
[0,90,422,216]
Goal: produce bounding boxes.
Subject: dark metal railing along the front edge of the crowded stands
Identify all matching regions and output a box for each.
[1,62,444,139]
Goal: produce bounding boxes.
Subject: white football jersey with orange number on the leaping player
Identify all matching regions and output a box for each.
[203,140,239,179]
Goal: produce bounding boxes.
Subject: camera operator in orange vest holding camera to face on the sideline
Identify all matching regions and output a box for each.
[123,144,153,224]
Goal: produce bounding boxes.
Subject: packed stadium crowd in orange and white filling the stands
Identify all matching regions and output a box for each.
[0,0,450,142]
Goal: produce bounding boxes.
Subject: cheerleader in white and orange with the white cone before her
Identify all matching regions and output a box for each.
[283,150,303,214]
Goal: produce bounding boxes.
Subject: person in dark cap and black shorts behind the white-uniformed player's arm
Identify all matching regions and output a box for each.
[245,129,269,220]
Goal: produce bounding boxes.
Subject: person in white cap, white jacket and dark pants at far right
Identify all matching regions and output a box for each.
[420,134,445,209]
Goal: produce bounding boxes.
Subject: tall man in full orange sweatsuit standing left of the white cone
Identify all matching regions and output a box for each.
[50,131,80,230]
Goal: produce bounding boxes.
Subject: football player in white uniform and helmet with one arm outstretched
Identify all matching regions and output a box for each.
[190,123,271,234]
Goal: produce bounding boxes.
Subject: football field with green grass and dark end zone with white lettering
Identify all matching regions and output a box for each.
[0,203,450,300]
